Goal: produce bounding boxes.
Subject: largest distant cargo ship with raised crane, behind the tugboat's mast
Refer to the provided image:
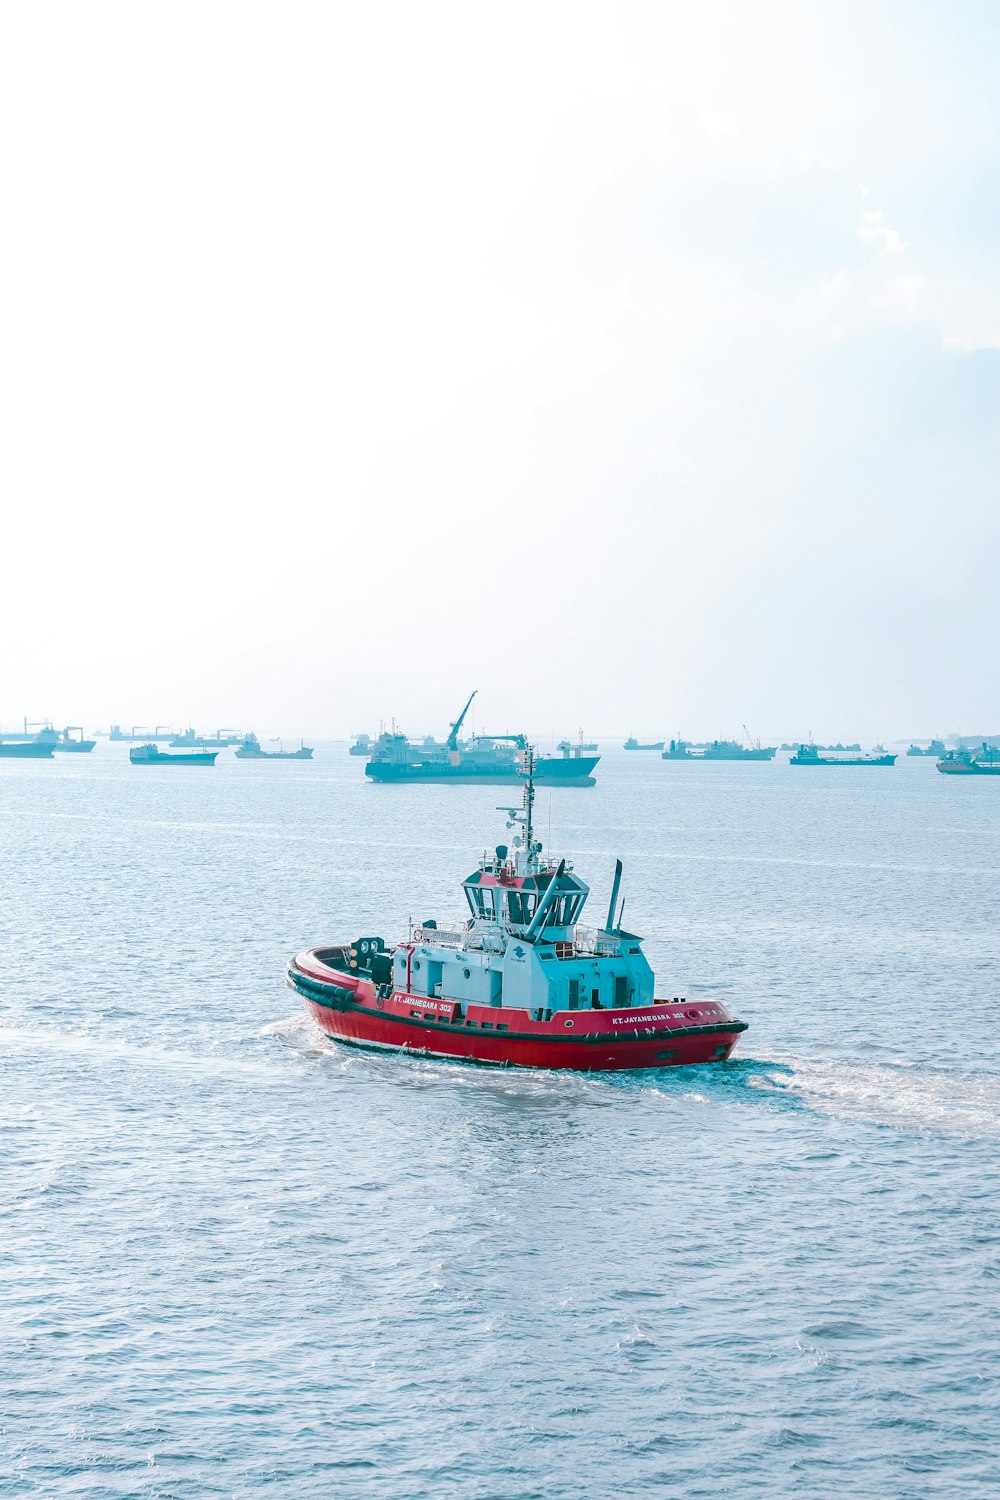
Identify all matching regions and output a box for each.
[364,693,600,786]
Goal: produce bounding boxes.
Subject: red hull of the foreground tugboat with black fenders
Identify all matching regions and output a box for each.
[288,953,747,1073]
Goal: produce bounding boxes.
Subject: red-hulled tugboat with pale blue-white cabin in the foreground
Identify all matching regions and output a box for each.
[288,750,747,1073]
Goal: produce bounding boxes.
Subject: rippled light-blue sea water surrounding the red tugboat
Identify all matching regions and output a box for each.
[0,756,1000,1500]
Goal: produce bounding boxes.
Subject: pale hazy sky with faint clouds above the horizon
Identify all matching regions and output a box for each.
[0,0,1000,738]
